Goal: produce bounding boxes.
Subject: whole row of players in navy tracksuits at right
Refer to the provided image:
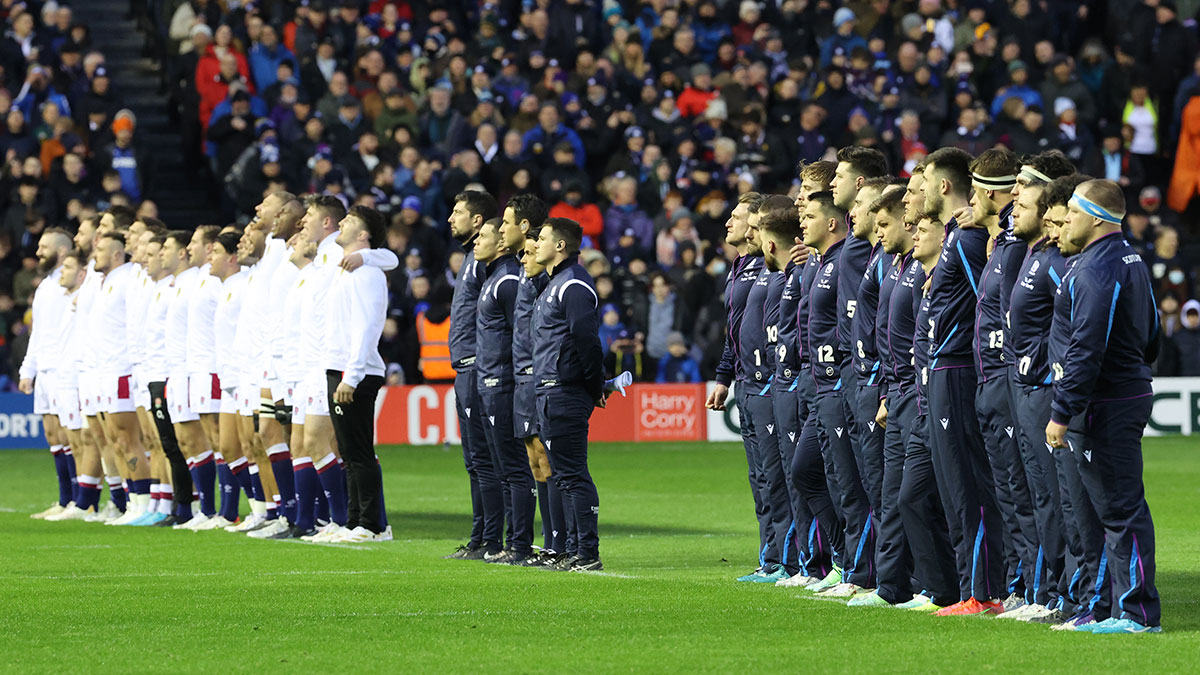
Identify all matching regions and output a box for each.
[706,147,1160,633]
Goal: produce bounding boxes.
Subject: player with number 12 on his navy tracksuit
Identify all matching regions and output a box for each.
[802,192,875,597]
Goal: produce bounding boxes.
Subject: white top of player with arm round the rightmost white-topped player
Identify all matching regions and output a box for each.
[300,232,400,377]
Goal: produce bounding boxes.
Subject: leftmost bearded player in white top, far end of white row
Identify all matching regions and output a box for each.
[18,228,74,519]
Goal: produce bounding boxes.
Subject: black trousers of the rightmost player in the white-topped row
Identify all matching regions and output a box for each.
[325,370,383,534]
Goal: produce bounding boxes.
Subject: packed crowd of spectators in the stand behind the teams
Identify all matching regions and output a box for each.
[0,0,1200,383]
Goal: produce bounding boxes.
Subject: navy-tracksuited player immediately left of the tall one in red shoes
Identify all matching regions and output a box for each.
[888,214,959,611]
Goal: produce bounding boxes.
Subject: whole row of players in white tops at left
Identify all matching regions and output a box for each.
[20,193,398,540]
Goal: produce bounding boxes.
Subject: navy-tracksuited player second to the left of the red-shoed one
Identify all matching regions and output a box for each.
[848,186,916,607]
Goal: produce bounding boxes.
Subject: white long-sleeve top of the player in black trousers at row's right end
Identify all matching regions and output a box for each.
[323,265,388,387]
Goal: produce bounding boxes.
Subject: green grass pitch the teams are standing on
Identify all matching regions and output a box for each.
[0,438,1200,673]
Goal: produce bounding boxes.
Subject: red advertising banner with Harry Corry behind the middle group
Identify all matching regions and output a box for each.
[376,384,707,446]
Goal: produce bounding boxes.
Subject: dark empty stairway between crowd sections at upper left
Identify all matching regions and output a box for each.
[73,0,221,229]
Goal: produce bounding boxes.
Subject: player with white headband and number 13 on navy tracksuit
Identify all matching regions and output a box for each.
[959,148,1038,614]
